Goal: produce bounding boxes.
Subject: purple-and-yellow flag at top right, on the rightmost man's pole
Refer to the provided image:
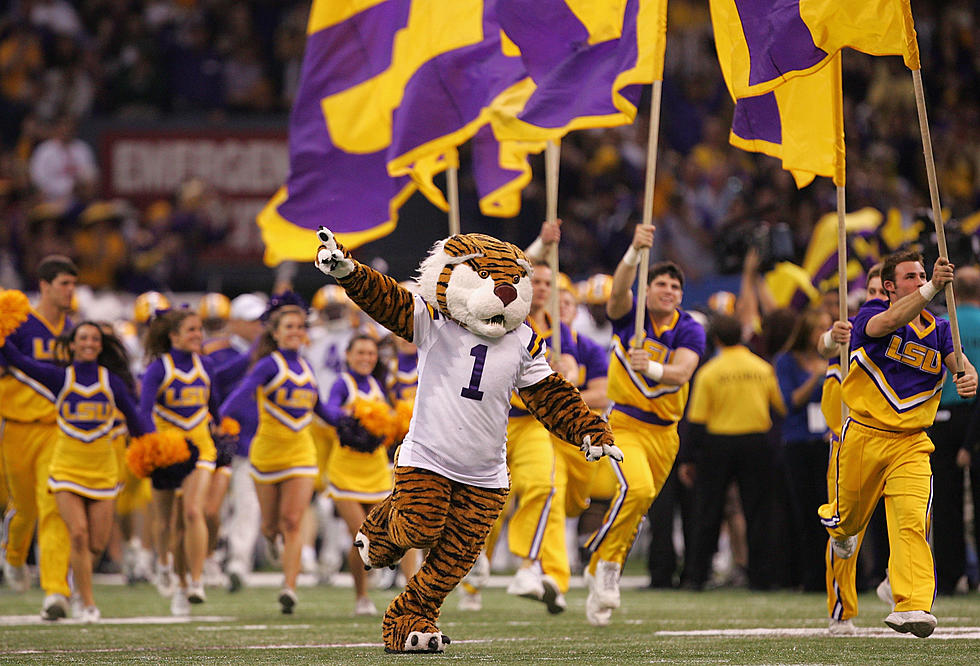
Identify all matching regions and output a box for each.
[710,0,919,98]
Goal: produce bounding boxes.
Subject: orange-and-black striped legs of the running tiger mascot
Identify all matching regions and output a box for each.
[361,467,508,652]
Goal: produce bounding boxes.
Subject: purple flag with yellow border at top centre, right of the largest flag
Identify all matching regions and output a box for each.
[472,0,667,217]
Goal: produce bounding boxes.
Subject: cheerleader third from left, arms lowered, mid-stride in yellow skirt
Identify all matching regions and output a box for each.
[220,292,329,614]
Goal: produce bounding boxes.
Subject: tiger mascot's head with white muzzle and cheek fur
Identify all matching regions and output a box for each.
[417,234,531,338]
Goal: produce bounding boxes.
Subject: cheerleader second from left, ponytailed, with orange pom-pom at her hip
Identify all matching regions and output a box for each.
[140,310,220,615]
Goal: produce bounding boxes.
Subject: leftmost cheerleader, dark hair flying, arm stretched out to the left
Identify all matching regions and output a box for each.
[0,321,152,623]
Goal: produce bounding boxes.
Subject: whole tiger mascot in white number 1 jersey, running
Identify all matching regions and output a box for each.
[316,227,623,652]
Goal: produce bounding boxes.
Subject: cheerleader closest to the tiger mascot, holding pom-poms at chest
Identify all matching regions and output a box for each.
[327,334,392,615]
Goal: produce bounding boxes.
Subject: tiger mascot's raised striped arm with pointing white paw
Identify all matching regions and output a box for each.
[315,227,415,342]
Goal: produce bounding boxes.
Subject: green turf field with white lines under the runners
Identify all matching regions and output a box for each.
[0,585,980,665]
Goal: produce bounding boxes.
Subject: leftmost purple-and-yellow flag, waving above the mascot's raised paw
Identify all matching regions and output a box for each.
[258,0,526,265]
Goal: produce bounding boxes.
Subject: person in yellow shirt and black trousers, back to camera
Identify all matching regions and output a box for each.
[687,315,786,589]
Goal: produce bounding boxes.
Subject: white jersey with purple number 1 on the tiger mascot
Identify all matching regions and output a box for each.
[397,296,554,488]
